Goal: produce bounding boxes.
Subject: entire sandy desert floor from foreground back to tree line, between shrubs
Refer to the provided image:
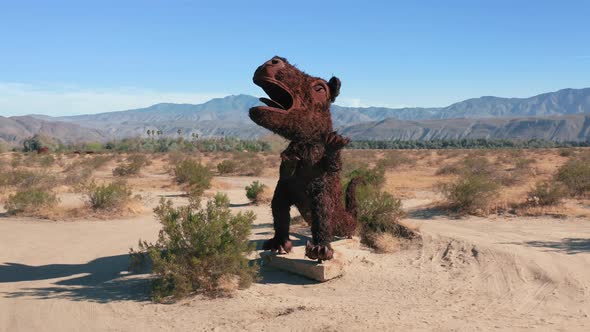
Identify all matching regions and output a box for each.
[0,149,590,332]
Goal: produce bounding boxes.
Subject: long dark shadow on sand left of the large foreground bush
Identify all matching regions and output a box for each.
[0,255,150,303]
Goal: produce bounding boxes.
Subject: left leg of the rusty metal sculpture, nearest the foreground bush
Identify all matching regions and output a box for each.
[262,180,293,252]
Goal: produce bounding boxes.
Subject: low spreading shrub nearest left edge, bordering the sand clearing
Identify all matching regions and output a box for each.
[4,188,58,214]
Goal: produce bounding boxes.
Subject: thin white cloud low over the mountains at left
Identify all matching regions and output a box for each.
[0,82,227,116]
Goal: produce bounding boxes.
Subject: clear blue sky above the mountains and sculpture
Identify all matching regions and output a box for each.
[0,0,590,116]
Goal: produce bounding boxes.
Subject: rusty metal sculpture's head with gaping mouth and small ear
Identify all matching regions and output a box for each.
[250,56,340,141]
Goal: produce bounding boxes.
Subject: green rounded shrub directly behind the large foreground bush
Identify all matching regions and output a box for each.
[174,159,213,196]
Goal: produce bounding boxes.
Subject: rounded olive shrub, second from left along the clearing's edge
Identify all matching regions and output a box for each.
[86,181,131,210]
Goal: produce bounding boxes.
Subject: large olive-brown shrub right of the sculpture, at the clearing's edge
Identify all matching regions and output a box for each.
[440,173,499,214]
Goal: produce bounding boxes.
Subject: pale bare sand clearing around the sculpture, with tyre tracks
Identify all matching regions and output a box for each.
[0,156,590,332]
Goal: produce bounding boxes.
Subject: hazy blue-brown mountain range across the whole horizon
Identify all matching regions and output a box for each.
[0,88,590,142]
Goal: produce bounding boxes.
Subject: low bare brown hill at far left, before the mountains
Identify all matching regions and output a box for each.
[0,116,105,145]
